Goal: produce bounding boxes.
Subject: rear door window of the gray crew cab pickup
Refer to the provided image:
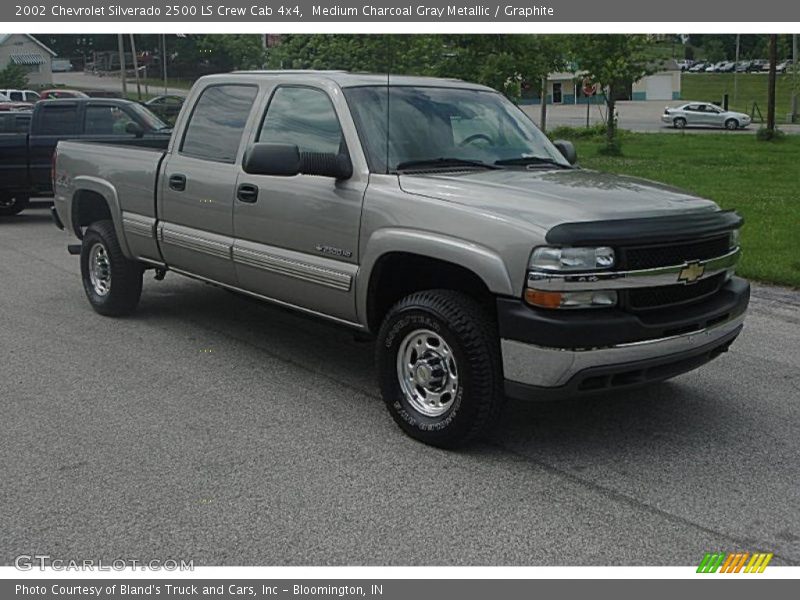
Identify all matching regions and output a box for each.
[181,85,258,163]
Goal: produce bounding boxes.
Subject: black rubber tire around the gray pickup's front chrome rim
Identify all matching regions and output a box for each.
[375,290,505,448]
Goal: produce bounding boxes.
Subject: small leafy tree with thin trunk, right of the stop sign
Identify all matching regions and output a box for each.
[572,34,656,153]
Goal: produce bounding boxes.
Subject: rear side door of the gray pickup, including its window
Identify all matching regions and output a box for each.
[158,83,258,285]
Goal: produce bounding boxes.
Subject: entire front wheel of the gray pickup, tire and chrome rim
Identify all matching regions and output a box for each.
[376,290,503,448]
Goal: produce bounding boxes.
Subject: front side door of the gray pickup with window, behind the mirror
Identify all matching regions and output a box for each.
[233,85,368,321]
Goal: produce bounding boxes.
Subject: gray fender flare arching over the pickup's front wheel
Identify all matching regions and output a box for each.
[356,227,514,325]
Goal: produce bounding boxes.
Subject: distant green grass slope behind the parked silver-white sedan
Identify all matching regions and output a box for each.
[681,73,800,123]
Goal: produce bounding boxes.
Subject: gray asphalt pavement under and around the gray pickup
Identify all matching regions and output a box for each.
[0,205,800,565]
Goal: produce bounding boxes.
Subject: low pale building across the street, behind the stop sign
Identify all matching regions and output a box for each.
[521,60,681,104]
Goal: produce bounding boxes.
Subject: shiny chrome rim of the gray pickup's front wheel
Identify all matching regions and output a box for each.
[397,329,459,417]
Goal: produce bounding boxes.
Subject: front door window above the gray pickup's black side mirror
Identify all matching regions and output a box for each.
[258,87,344,154]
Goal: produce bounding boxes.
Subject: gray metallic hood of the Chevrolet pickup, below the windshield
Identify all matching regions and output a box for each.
[399,169,718,230]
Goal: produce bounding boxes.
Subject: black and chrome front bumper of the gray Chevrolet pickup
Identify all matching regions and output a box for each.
[498,277,750,399]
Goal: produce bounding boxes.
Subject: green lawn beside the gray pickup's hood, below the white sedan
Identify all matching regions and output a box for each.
[575,133,800,288]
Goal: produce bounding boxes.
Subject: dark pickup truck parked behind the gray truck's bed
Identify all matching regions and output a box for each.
[0,98,171,216]
